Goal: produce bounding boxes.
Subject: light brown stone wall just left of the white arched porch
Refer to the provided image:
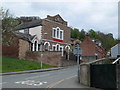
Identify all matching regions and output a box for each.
[18,39,30,59]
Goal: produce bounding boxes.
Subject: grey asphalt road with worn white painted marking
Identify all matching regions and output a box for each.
[0,66,88,88]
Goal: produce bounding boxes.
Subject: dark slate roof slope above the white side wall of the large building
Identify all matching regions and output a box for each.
[15,19,42,30]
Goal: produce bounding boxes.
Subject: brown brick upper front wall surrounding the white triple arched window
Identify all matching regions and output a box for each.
[42,19,71,43]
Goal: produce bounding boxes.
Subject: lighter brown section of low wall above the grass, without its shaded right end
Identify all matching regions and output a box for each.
[26,51,61,66]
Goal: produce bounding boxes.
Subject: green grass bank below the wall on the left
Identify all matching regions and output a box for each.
[0,57,56,73]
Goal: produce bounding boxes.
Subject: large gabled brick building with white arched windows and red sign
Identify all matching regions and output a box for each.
[16,14,71,51]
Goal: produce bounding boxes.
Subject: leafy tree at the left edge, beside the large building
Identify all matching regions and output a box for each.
[0,8,20,46]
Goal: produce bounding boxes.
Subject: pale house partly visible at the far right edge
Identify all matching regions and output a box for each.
[111,44,120,57]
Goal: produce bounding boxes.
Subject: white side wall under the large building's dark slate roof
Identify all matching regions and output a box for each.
[29,26,42,40]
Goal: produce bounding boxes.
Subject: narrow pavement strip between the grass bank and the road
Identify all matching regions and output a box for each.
[0,67,64,76]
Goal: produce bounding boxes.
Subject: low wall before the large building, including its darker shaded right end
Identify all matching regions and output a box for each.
[25,51,77,66]
